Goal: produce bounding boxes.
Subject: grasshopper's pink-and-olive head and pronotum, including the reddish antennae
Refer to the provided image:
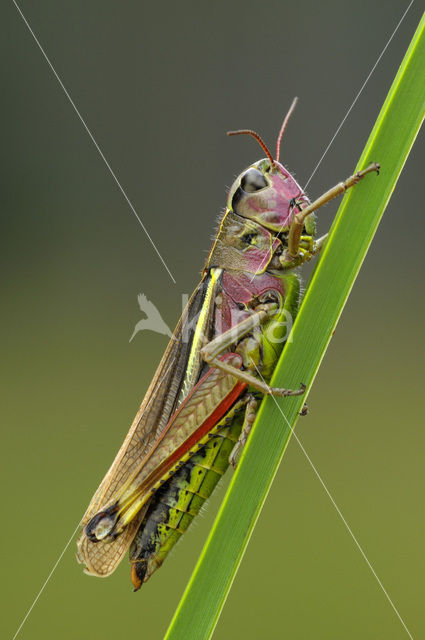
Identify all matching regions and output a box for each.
[206,99,315,274]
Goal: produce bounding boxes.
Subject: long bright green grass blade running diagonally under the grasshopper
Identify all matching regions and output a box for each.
[166,17,425,640]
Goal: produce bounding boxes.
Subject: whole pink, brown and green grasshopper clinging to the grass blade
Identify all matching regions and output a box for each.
[77,99,379,590]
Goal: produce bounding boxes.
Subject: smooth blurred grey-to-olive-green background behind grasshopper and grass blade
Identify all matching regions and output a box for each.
[0,0,425,640]
